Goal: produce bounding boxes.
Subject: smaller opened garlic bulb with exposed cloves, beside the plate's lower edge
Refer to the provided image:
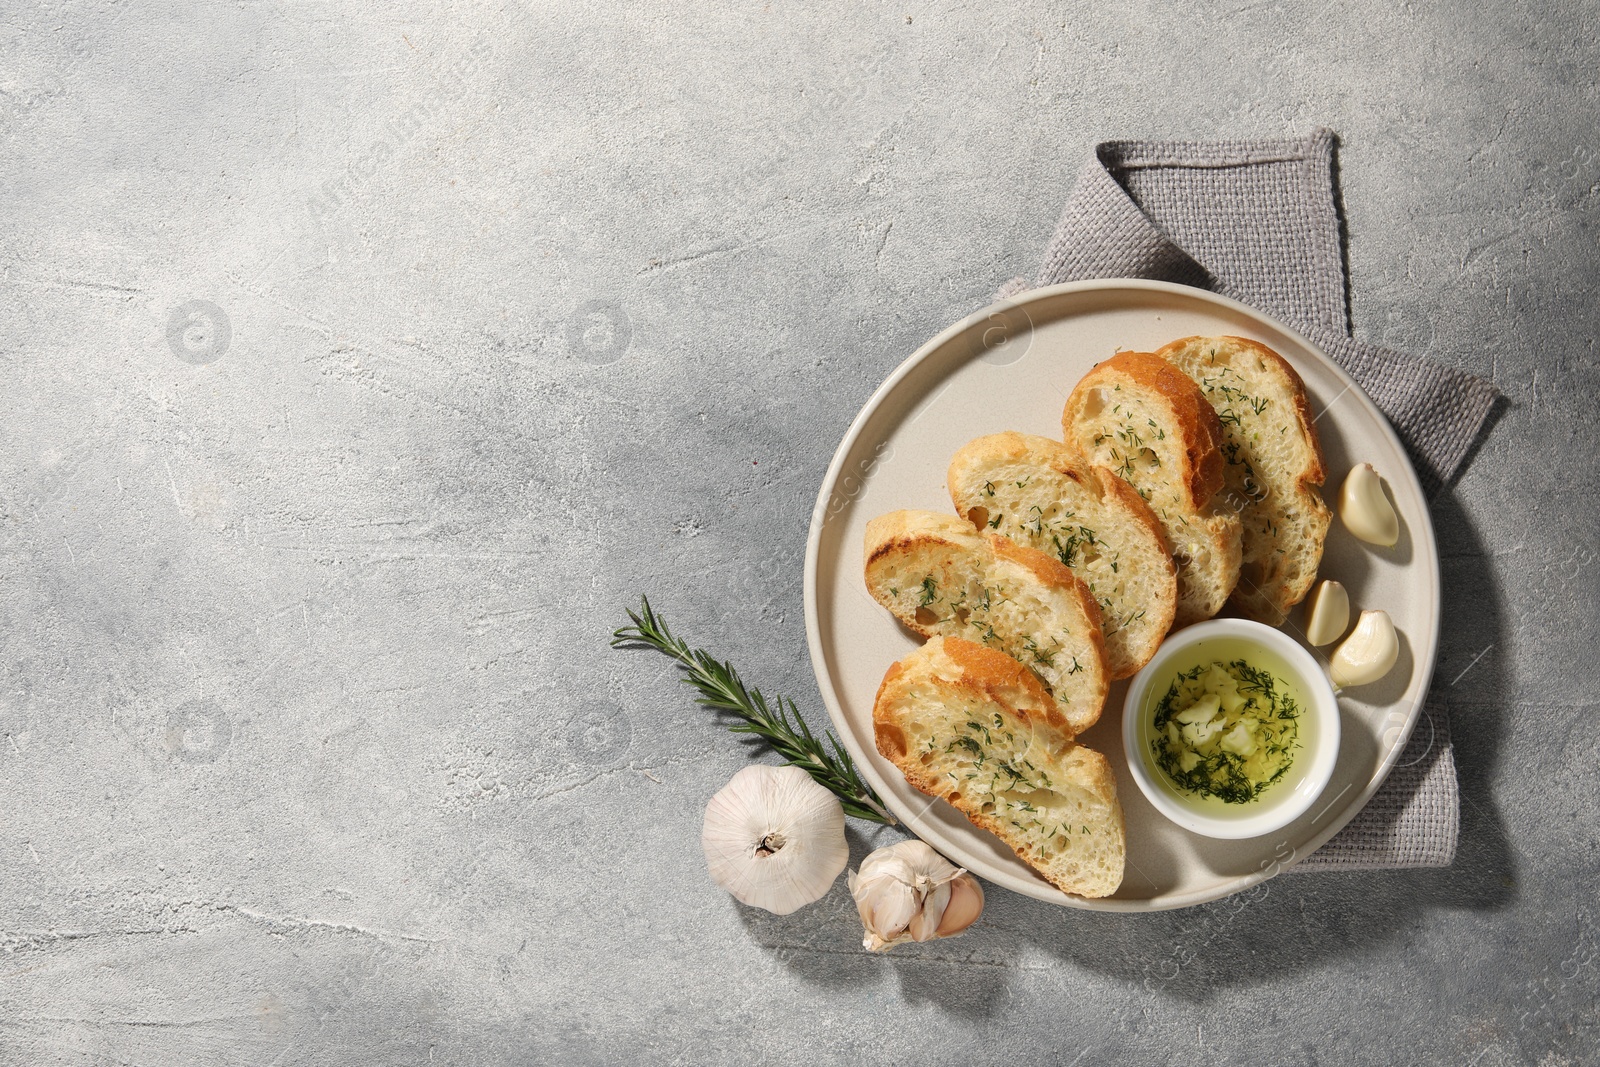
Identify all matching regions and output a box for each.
[850,840,984,952]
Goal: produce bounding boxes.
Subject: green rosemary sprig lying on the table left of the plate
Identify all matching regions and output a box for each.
[611,597,896,825]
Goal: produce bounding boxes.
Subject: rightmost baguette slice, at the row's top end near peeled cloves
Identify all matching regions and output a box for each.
[1157,338,1333,625]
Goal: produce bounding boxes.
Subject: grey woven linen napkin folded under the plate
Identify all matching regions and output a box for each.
[1000,130,1499,872]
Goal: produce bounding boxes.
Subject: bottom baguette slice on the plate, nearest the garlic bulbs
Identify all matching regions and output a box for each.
[872,637,1126,897]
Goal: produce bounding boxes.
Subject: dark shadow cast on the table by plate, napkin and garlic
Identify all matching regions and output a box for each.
[742,494,1515,1019]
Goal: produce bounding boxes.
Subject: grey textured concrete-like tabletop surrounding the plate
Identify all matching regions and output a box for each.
[0,0,1600,1065]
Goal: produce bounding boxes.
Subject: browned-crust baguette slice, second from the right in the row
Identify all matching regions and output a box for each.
[1061,352,1242,627]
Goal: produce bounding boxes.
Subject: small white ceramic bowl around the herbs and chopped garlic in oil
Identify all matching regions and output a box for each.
[1122,619,1339,840]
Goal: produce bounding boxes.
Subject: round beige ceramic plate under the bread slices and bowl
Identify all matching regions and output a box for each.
[805,280,1440,912]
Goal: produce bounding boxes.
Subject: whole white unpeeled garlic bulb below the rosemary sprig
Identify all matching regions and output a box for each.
[701,765,850,915]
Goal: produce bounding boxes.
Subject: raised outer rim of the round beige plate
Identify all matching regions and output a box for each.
[802,278,1443,913]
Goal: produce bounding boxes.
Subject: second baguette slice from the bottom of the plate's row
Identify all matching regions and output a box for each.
[866,512,1110,734]
